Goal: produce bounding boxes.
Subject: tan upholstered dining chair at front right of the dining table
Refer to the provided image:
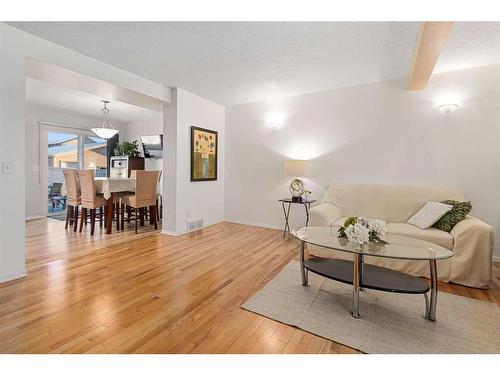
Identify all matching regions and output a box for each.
[121,170,160,234]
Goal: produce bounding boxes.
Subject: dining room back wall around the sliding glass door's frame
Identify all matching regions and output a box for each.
[25,105,128,218]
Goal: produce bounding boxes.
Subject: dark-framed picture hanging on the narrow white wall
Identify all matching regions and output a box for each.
[191,126,217,181]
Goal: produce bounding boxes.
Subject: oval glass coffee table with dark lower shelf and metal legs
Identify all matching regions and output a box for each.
[292,226,453,320]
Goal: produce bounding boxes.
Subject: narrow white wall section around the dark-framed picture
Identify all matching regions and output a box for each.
[164,88,225,234]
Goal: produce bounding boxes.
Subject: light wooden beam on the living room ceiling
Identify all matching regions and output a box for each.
[408,22,453,90]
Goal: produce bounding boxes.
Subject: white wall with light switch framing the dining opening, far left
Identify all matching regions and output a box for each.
[0,23,170,282]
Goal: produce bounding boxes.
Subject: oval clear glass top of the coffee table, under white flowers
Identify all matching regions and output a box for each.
[291,226,453,260]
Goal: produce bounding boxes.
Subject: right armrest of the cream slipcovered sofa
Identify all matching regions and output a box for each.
[450,216,494,288]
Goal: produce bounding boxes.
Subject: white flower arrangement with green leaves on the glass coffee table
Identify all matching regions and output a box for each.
[338,216,387,245]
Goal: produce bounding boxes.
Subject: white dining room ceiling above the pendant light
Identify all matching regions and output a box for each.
[26,78,162,123]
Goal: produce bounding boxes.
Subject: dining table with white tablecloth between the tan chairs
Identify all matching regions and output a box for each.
[61,177,135,234]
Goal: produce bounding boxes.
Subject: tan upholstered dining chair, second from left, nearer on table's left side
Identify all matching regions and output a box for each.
[78,169,107,236]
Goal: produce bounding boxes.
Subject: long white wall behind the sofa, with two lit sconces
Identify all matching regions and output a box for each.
[225,65,500,256]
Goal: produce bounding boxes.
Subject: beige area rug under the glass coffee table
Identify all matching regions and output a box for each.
[242,261,500,353]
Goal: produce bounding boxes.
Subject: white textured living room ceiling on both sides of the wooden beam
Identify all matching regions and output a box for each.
[10,22,500,105]
